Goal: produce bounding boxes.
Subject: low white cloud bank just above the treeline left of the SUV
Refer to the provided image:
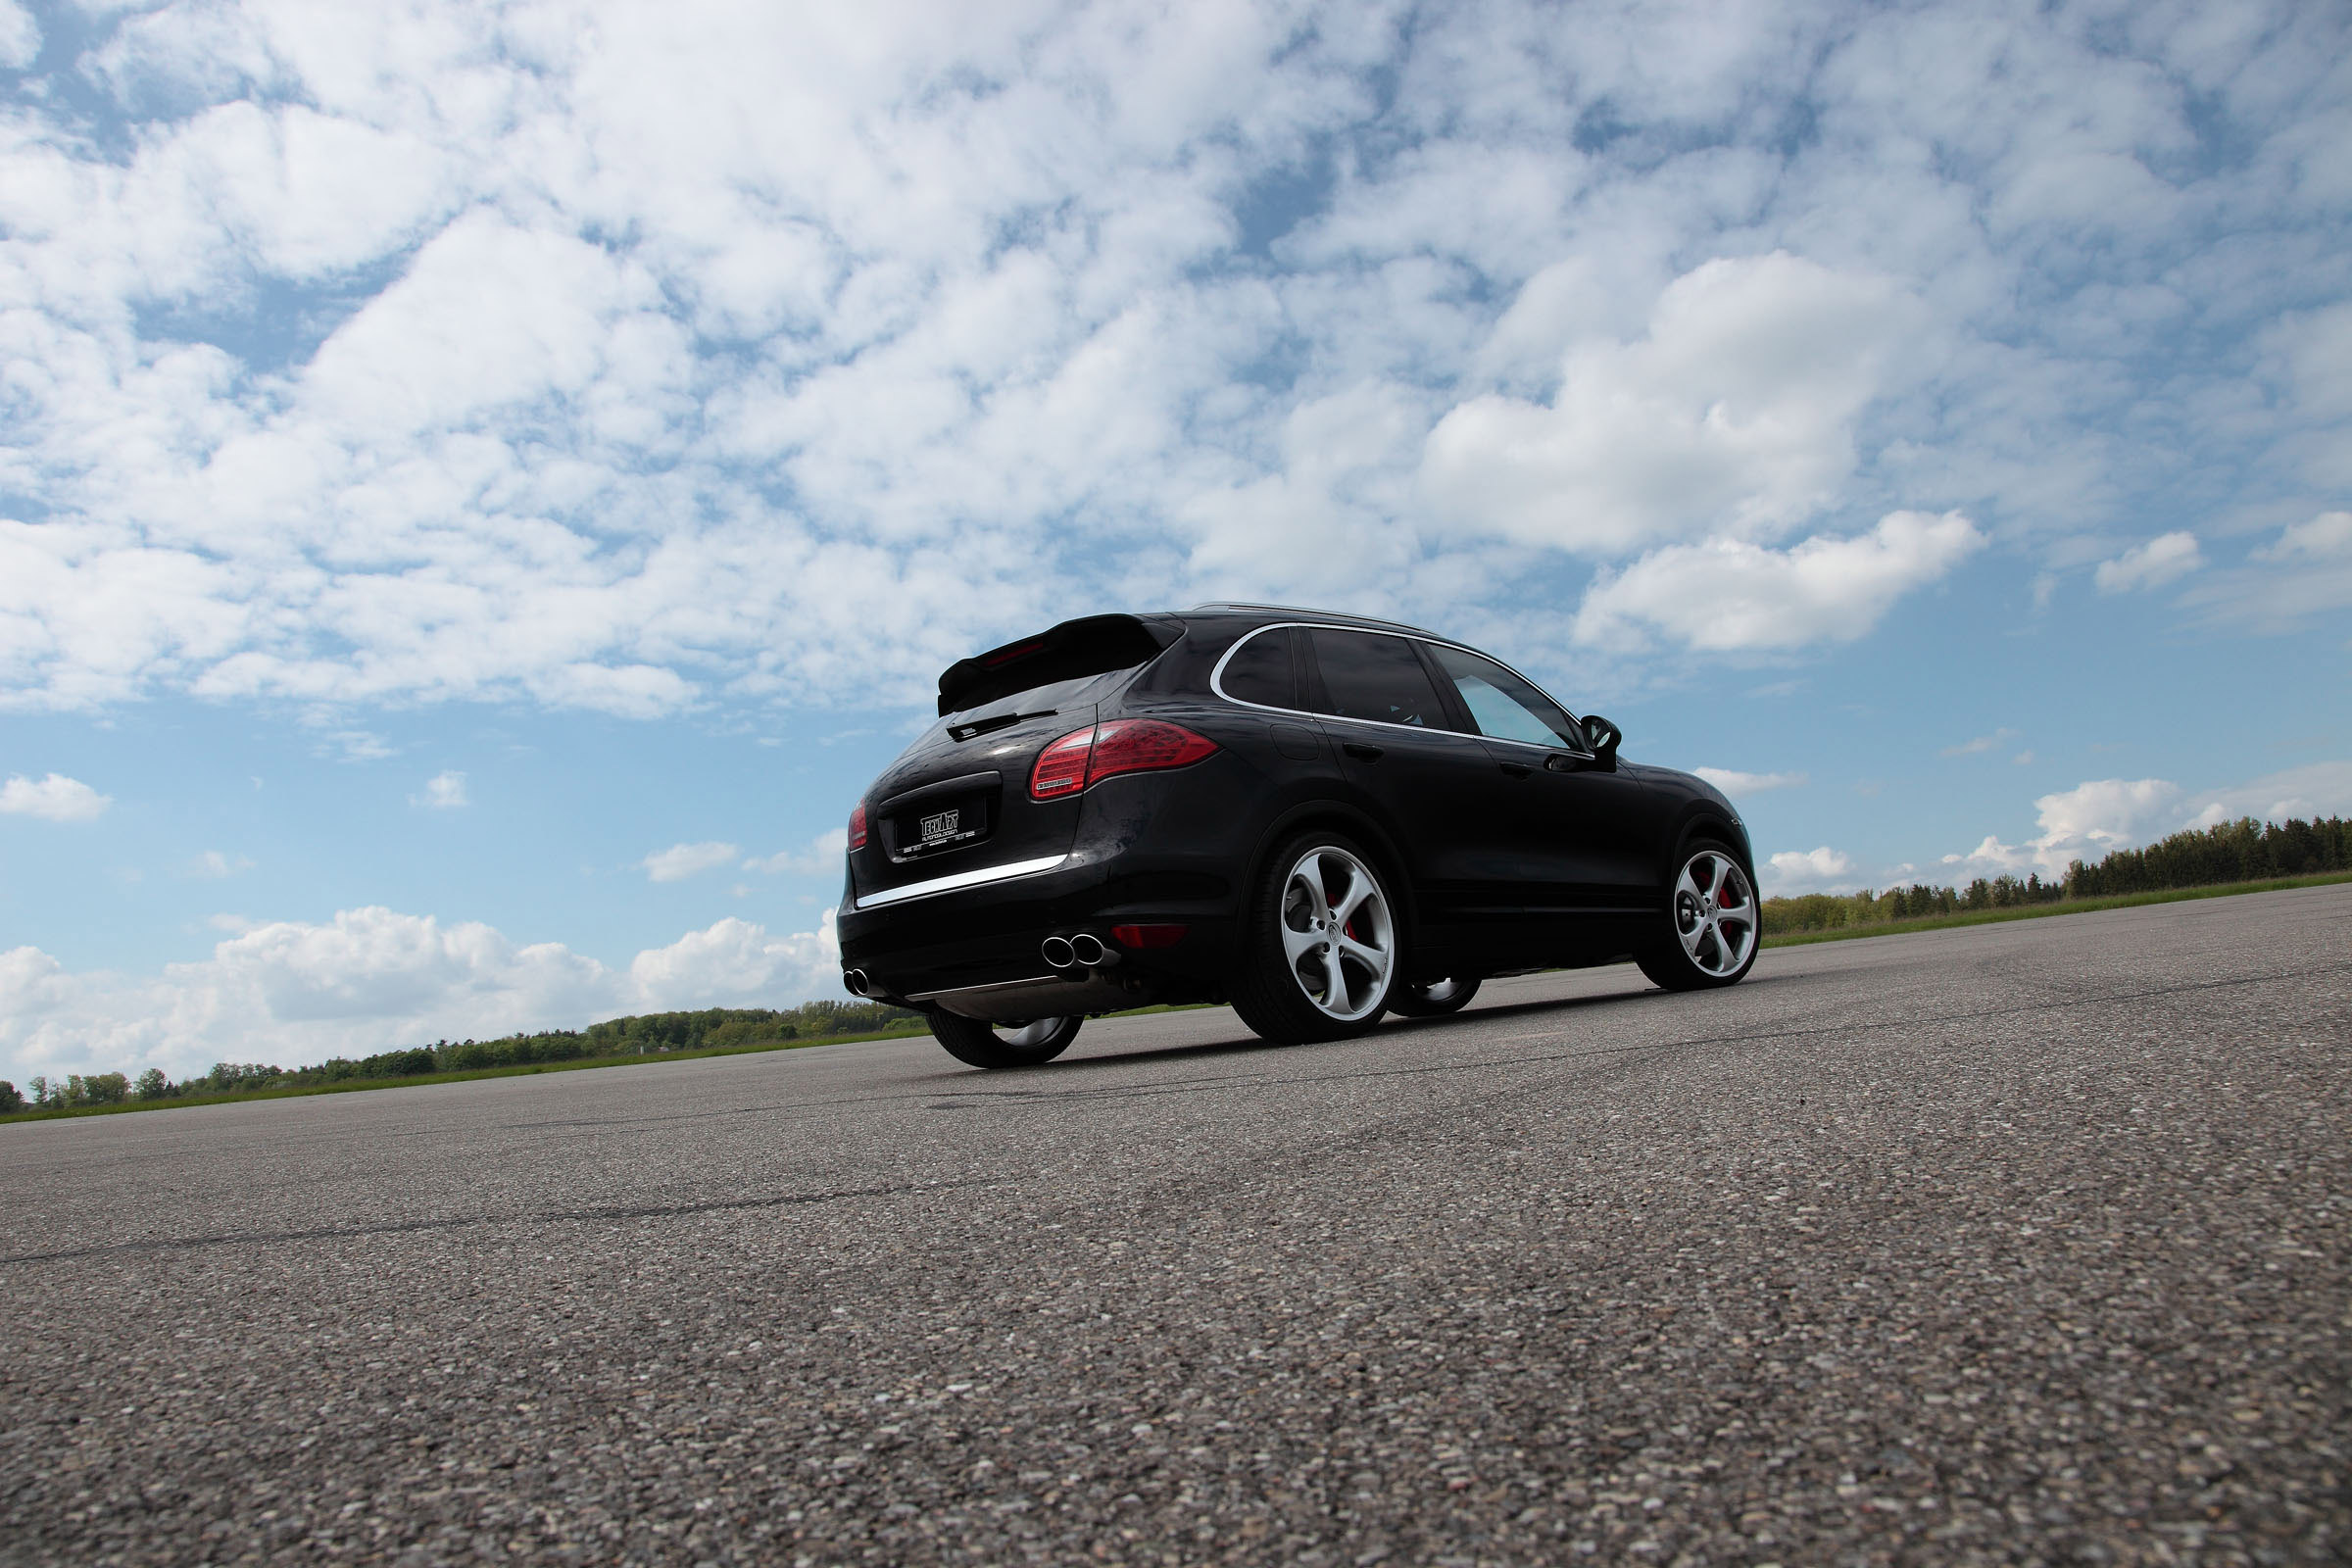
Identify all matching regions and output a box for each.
[0,907,842,1086]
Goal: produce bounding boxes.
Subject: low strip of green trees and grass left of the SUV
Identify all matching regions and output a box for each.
[0,1002,922,1114]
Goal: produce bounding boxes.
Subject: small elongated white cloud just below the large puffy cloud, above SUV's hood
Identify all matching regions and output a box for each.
[1576,513,1985,651]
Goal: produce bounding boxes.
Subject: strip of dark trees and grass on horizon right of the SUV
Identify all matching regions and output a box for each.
[1764,815,2352,936]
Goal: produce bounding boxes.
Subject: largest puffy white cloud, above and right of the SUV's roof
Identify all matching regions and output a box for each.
[1423,252,1922,555]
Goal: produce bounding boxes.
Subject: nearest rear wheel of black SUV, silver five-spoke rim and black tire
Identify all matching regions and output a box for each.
[1228,827,1404,1046]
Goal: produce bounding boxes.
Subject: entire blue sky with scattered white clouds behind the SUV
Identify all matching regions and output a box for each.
[0,0,2352,1084]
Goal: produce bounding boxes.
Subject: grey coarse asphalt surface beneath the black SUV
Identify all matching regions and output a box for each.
[0,886,2352,1568]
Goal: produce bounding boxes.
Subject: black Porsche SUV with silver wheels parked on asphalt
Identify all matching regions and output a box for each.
[840,604,1759,1067]
